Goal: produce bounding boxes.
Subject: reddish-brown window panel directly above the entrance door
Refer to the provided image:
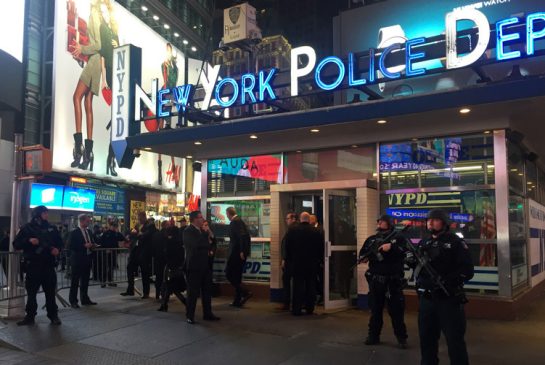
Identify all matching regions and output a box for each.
[284,146,376,184]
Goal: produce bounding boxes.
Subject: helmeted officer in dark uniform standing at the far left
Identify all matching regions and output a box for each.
[13,205,63,326]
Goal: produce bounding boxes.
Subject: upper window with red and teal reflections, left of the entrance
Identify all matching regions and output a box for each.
[207,155,284,198]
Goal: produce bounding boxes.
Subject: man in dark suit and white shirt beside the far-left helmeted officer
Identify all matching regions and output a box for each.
[69,214,97,309]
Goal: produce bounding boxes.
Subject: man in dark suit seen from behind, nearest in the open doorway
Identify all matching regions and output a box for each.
[285,212,324,316]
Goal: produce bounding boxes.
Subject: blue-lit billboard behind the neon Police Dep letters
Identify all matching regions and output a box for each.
[333,0,544,101]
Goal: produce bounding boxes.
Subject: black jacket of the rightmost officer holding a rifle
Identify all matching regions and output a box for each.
[416,231,474,291]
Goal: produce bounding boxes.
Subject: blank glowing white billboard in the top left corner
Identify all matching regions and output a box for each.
[0,0,26,62]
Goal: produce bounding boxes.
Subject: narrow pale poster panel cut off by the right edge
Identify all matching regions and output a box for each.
[528,200,545,286]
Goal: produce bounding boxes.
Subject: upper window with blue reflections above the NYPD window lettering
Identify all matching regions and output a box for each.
[380,134,494,190]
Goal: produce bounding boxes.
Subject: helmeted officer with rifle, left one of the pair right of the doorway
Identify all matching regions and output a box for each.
[359,215,407,349]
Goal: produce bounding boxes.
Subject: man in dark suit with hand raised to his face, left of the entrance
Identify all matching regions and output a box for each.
[183,211,220,324]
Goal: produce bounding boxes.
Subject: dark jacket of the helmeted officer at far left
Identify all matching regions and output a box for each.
[13,219,63,266]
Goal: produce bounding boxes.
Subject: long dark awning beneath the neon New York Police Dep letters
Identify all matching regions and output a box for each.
[127,75,545,159]
